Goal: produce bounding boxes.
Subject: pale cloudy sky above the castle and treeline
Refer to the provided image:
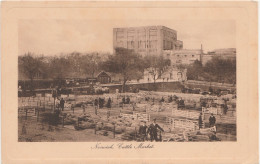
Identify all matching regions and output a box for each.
[18,19,236,55]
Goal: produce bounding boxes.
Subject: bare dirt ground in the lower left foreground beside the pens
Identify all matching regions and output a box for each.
[18,118,119,142]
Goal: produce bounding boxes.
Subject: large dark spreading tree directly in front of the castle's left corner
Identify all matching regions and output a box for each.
[103,48,144,92]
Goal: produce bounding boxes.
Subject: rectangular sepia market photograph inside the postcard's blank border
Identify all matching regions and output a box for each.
[18,20,237,142]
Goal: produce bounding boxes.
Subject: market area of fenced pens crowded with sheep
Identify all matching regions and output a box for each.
[18,92,236,142]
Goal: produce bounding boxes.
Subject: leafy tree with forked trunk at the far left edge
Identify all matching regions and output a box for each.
[18,52,45,92]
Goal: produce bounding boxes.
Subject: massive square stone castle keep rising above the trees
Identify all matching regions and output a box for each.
[113,26,183,56]
